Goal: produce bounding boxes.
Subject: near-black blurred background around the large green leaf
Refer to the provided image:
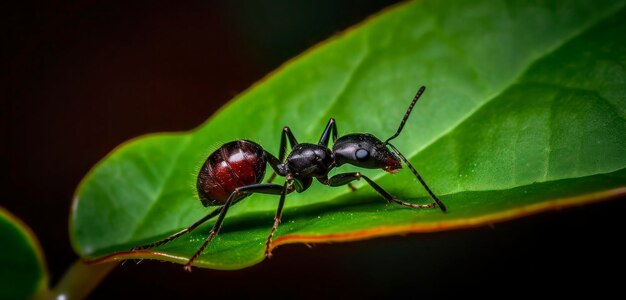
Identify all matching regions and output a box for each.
[0,0,625,298]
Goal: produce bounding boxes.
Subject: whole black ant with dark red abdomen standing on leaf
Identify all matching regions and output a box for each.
[132,86,446,271]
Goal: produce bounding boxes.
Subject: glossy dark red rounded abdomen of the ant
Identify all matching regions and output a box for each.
[196,140,266,206]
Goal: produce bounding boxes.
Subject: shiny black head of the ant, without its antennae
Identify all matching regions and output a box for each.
[333,133,402,172]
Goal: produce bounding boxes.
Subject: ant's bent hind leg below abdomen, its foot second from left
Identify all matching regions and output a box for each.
[185,184,283,272]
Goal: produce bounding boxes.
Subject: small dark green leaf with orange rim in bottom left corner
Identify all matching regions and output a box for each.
[0,207,48,299]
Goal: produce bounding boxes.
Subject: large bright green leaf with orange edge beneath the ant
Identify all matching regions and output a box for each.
[71,0,626,269]
